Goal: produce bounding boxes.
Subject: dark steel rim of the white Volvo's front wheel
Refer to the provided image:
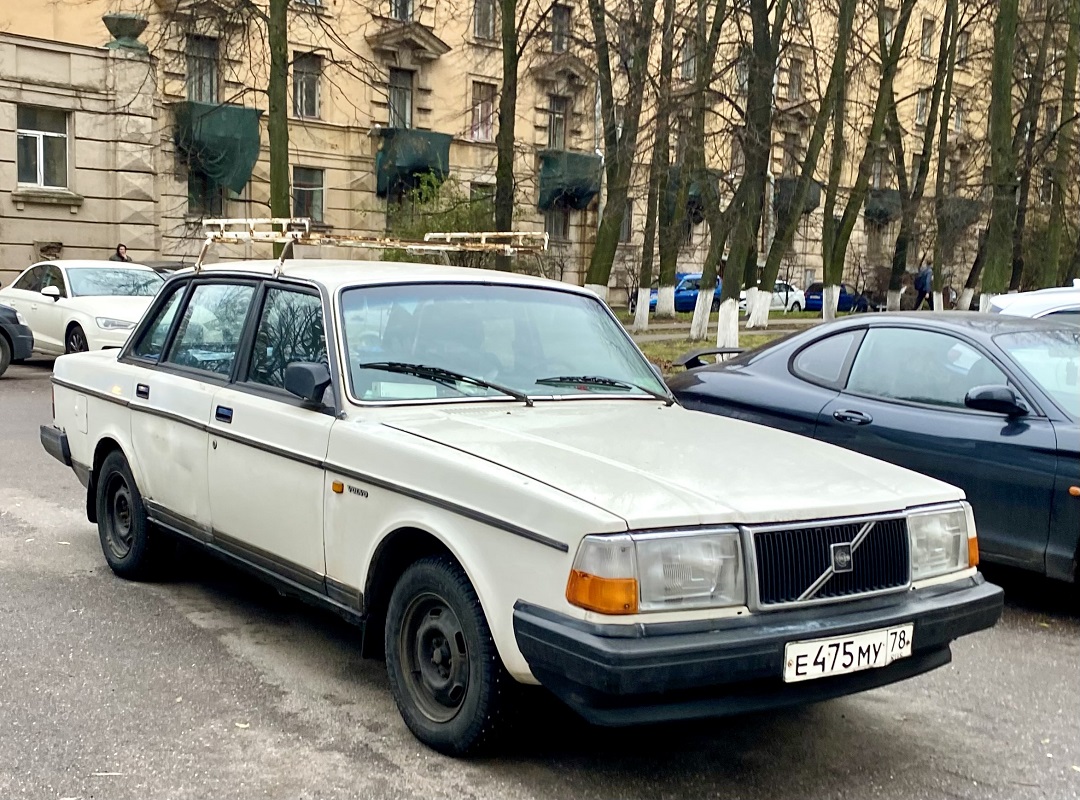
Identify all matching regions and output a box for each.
[397,594,469,722]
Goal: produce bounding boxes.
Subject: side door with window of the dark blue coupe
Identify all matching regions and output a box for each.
[814,326,1056,571]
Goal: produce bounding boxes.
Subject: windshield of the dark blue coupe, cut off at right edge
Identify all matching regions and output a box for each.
[994,327,1080,418]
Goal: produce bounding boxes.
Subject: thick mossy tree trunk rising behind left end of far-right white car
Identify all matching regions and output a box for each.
[983,0,1018,291]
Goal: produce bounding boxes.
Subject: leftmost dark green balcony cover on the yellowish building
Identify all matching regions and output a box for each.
[173,100,262,193]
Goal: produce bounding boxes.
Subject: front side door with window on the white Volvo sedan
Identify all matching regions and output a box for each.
[208,283,336,592]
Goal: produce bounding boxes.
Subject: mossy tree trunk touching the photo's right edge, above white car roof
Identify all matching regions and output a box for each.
[1038,0,1080,286]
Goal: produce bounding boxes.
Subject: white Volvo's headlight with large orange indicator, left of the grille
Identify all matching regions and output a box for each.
[566,531,746,614]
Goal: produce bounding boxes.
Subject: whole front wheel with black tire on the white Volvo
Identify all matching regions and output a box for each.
[386,556,516,756]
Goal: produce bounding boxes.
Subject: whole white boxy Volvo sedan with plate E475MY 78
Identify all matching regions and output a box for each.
[41,260,1002,755]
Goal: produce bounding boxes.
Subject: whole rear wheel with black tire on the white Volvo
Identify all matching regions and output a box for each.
[94,450,162,581]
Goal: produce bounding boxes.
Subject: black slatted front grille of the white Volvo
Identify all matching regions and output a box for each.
[754,518,910,606]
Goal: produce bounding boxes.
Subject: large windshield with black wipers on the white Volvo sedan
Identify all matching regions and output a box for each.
[341,284,667,403]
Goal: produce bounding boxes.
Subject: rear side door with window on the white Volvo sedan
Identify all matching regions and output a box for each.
[124,279,255,540]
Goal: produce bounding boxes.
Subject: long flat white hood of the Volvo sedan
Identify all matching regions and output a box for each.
[383,399,963,529]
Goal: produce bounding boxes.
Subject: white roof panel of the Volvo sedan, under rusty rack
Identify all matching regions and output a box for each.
[173,258,596,297]
